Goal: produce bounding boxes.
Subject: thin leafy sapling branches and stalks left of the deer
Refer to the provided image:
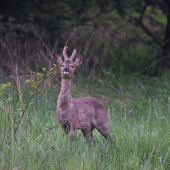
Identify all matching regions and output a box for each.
[0,64,58,143]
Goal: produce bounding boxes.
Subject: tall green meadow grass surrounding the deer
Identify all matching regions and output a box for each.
[0,73,170,170]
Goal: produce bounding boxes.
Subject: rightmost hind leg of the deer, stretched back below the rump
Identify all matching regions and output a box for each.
[96,123,114,143]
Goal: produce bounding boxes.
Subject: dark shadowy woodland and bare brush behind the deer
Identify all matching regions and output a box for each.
[0,0,170,76]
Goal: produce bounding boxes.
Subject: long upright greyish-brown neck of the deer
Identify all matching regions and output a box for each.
[58,79,71,110]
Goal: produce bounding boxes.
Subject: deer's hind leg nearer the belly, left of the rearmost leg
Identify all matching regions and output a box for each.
[81,125,95,146]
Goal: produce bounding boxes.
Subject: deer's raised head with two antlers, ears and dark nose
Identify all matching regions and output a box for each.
[54,46,83,79]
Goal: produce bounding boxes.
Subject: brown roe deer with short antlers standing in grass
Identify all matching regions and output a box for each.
[55,46,113,145]
